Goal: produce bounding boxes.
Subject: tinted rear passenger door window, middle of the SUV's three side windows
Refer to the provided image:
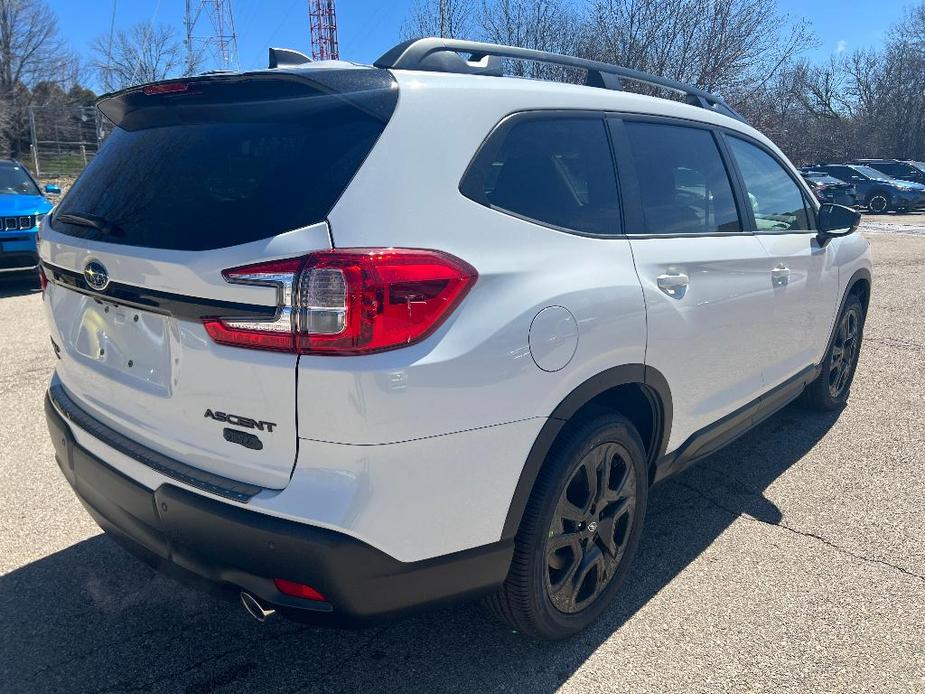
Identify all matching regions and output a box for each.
[624,121,742,234]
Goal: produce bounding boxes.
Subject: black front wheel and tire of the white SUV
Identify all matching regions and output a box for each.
[803,294,864,412]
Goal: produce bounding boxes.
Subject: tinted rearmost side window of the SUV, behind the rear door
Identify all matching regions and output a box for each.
[459,117,620,235]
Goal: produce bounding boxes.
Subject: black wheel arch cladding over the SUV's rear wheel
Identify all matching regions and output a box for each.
[501,364,672,539]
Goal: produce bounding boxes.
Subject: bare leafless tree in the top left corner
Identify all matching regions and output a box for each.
[0,0,78,156]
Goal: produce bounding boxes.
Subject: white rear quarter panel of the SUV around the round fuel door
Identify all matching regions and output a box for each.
[299,71,648,446]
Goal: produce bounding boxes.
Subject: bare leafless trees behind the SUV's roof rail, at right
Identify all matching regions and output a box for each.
[405,0,925,163]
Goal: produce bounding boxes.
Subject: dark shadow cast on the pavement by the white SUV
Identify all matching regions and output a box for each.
[0,405,838,693]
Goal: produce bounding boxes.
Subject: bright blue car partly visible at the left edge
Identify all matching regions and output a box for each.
[0,159,61,277]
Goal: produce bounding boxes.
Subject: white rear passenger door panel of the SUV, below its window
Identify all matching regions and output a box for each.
[632,234,774,452]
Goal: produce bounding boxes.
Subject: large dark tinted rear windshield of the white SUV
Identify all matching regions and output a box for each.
[53,70,397,251]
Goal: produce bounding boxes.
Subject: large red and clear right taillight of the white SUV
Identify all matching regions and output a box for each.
[204,248,478,354]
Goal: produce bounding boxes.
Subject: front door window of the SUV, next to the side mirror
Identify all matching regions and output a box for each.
[728,137,810,232]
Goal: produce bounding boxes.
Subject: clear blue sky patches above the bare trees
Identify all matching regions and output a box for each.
[47,0,909,92]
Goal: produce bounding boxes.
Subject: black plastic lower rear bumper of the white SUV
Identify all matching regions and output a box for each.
[45,396,513,625]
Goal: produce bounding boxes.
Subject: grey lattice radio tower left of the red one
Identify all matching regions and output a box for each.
[184,0,238,74]
